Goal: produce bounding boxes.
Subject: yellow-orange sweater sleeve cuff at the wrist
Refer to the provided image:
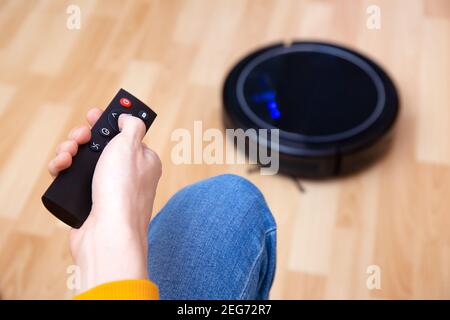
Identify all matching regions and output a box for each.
[73,280,159,300]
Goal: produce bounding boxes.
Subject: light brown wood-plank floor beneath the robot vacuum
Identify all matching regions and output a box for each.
[0,0,450,299]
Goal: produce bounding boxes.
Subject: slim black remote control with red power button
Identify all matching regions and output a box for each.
[42,89,156,228]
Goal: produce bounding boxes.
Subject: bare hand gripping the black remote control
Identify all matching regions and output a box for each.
[49,109,161,291]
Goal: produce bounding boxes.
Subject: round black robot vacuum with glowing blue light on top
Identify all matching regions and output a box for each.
[223,42,399,178]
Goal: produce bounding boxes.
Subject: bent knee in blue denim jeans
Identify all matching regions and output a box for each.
[148,174,276,300]
